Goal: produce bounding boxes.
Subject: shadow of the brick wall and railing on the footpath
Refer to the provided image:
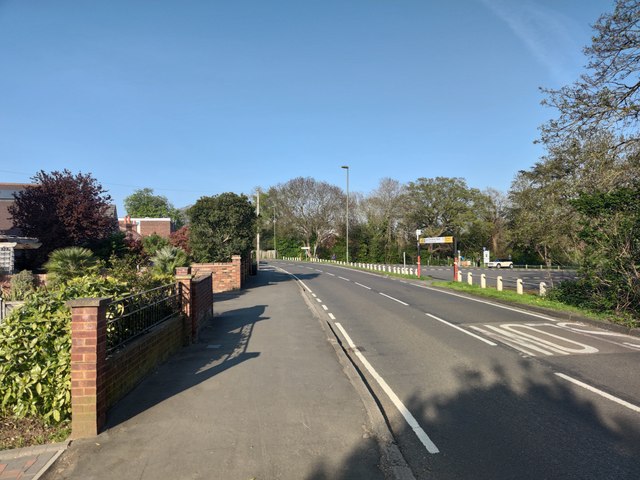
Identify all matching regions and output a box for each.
[106,302,269,429]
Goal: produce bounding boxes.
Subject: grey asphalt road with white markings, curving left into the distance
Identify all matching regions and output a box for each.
[262,261,640,480]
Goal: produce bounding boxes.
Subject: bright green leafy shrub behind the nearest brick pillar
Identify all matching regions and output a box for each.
[0,276,129,424]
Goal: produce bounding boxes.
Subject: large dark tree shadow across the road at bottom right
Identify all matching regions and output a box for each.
[391,360,640,480]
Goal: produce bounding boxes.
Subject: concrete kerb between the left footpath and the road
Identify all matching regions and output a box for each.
[298,283,416,480]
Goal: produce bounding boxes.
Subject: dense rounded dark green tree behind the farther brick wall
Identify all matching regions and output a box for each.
[188,193,256,262]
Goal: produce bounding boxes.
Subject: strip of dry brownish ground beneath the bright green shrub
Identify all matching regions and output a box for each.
[0,417,71,450]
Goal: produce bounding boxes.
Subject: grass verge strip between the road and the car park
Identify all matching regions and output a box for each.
[432,281,640,328]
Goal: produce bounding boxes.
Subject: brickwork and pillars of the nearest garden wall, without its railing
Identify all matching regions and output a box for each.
[68,272,215,438]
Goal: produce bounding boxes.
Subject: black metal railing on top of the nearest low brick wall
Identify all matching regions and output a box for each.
[107,284,181,354]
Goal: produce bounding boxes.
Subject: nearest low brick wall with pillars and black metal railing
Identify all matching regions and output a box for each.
[68,269,213,438]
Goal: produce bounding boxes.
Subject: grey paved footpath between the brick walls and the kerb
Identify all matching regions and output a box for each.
[37,267,404,480]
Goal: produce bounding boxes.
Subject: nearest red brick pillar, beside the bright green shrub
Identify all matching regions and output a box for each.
[67,298,111,438]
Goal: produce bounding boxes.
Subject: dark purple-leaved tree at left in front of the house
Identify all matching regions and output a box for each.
[9,170,117,261]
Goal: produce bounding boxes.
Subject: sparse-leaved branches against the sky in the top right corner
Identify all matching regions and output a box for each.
[542,0,640,146]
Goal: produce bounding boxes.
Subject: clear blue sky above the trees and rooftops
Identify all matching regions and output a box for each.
[0,0,613,216]
